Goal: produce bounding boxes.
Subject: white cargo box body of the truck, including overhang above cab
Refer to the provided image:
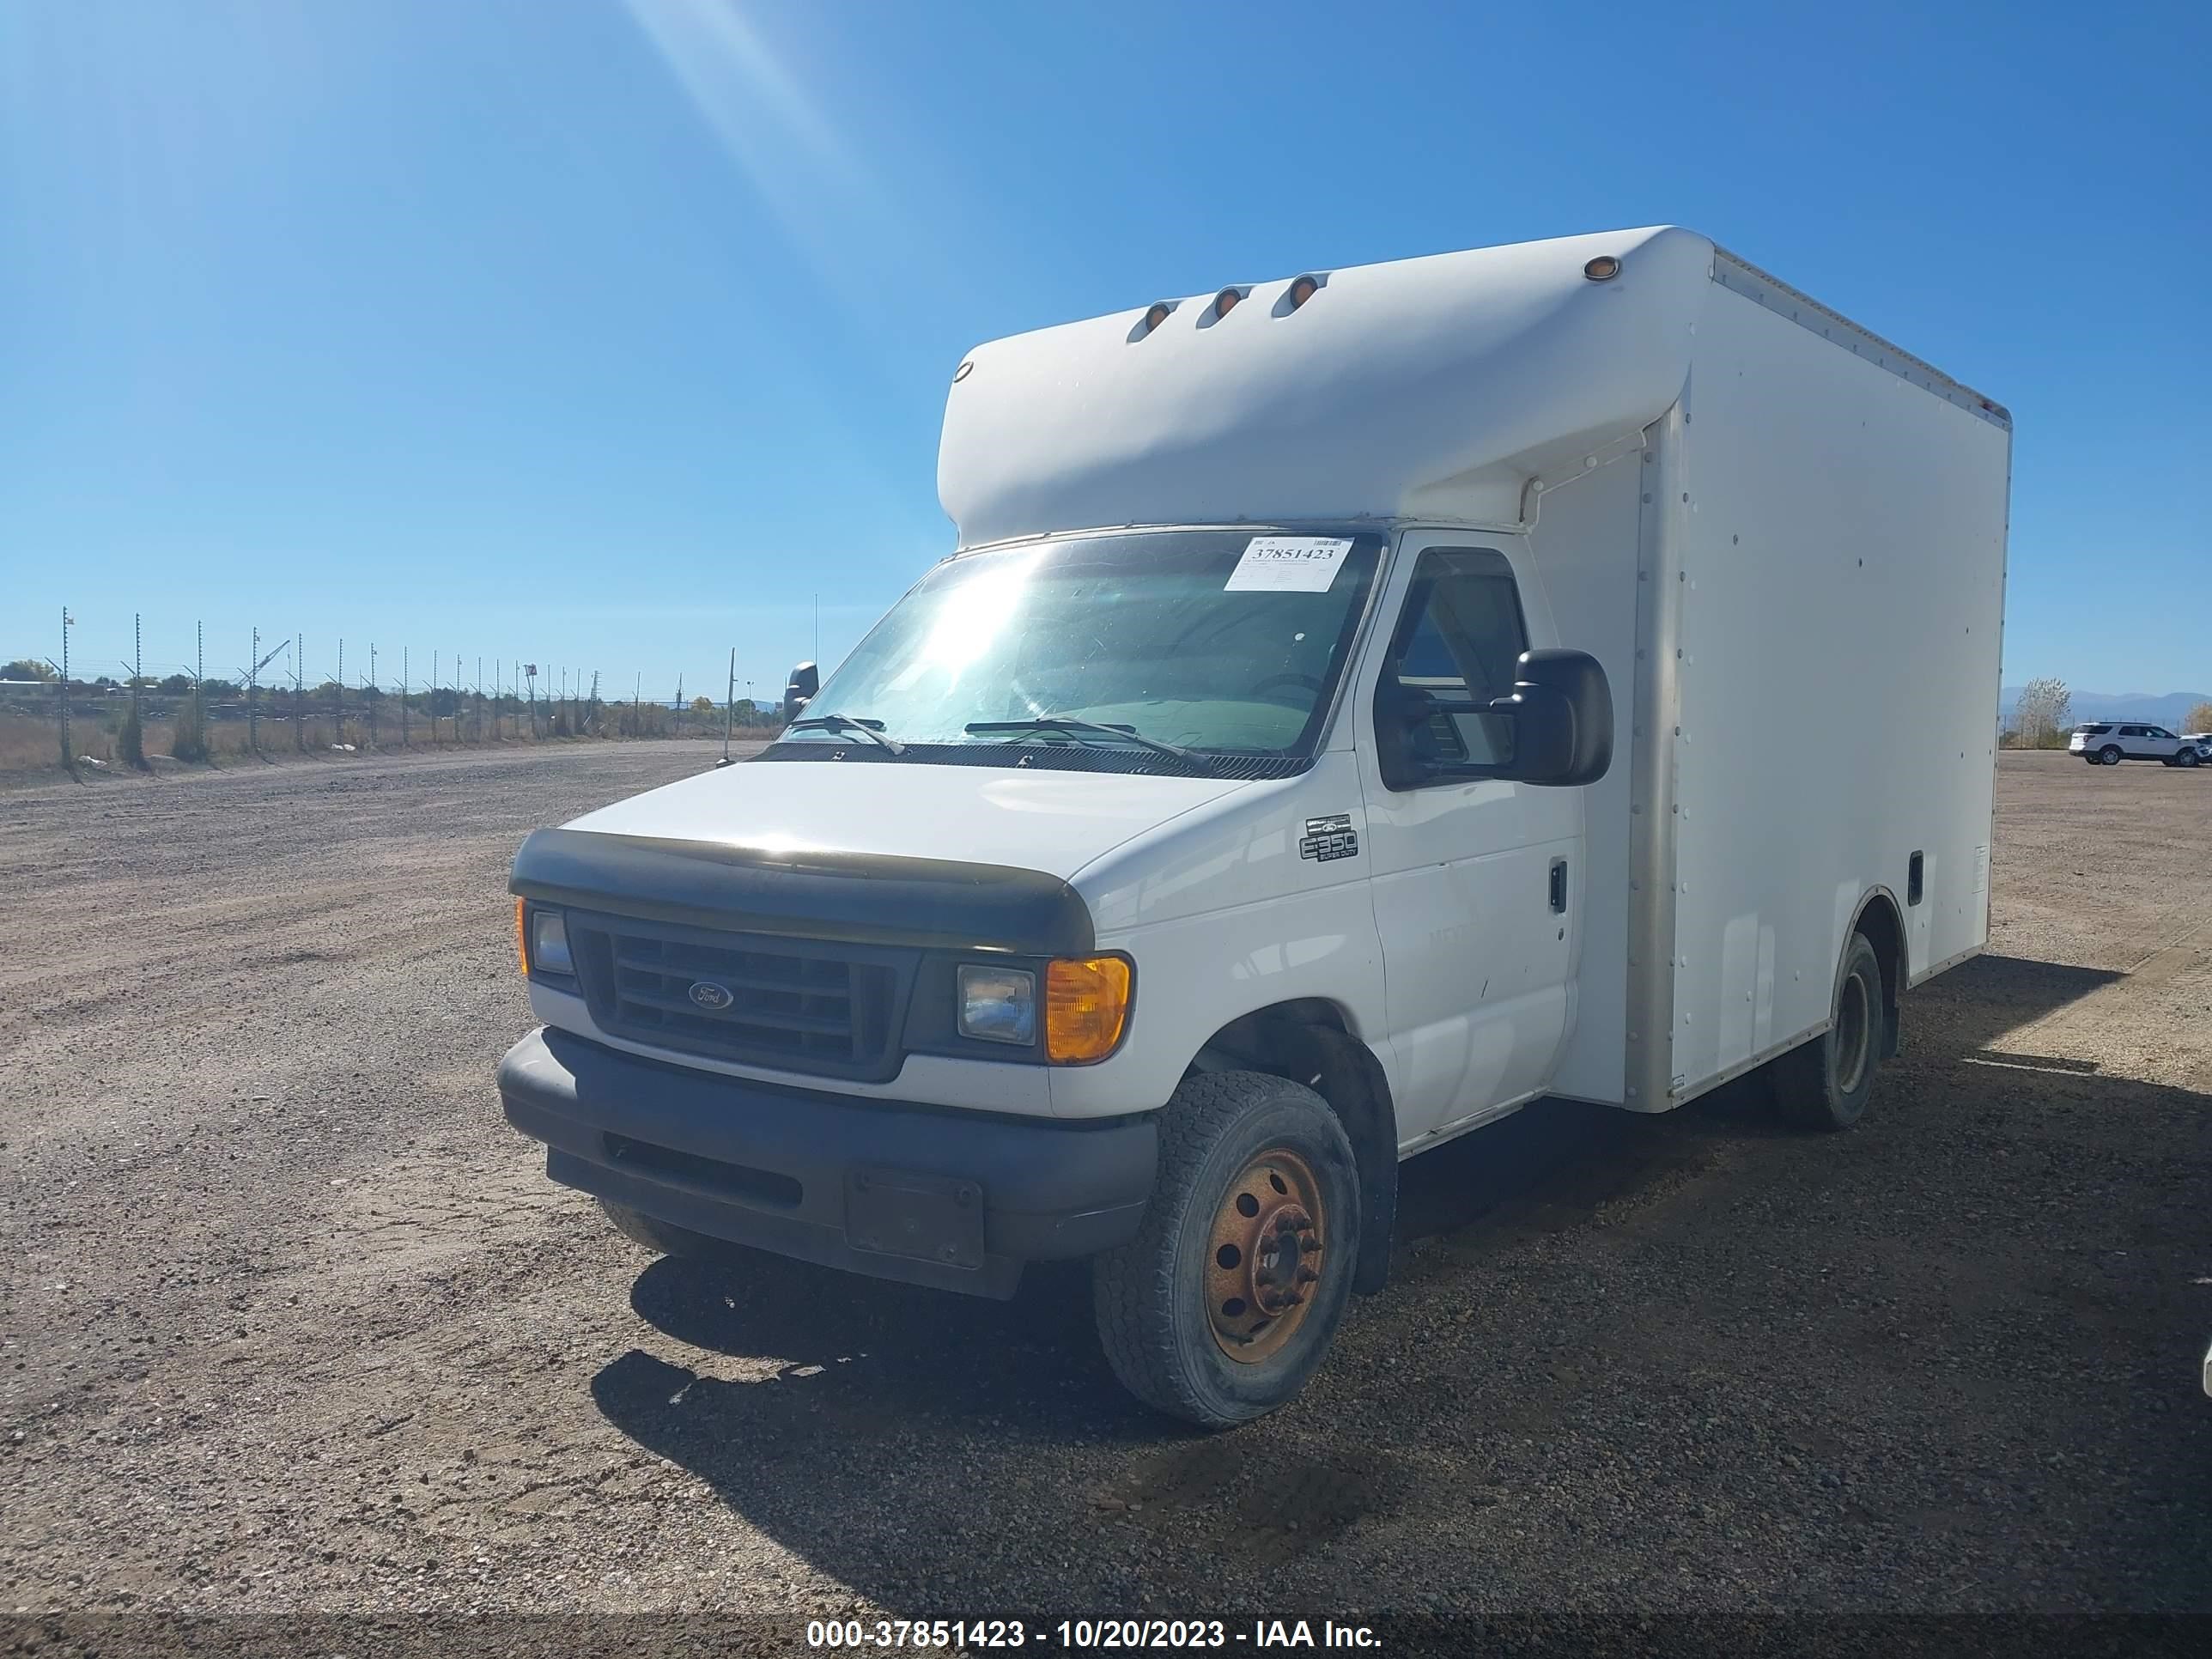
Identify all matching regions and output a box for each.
[938,228,2011,1110]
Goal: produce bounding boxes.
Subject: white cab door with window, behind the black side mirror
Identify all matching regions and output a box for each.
[1356,533,1582,1148]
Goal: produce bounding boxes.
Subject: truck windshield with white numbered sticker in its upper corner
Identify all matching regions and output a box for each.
[769,531,1382,761]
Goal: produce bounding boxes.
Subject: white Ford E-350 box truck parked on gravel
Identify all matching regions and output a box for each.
[500,228,2011,1425]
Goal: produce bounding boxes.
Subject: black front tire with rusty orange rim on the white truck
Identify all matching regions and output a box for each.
[1091,1071,1360,1429]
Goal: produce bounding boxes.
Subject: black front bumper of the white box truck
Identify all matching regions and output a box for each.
[500,1029,1159,1297]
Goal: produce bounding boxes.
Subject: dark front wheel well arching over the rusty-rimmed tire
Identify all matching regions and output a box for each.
[1190,998,1398,1294]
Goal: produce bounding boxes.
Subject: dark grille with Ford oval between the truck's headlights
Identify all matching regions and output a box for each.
[568,914,914,1082]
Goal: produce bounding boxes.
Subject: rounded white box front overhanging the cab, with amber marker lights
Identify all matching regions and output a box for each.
[938,226,2002,546]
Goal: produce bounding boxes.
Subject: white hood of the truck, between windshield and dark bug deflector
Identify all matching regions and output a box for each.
[566,761,1249,880]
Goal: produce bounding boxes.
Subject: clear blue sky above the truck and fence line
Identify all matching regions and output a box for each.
[0,0,2212,695]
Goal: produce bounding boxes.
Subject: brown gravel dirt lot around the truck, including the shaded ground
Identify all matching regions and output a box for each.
[0,745,2212,1650]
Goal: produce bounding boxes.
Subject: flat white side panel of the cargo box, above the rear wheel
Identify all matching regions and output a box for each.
[1662,285,2011,1099]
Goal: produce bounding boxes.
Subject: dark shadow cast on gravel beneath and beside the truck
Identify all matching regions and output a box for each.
[591,957,2212,1617]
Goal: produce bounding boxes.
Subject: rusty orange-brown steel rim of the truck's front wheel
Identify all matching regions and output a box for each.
[1206,1146,1329,1364]
